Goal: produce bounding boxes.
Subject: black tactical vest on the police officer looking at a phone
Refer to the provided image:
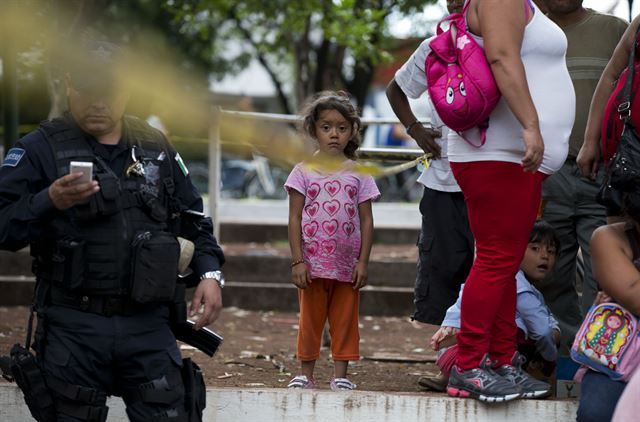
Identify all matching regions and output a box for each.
[32,116,176,296]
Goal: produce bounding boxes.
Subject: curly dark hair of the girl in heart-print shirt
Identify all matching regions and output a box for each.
[300,91,362,160]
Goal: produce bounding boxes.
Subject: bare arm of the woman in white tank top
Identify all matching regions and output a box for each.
[467,0,544,172]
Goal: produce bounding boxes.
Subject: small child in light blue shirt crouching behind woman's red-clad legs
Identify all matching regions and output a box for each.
[418,220,560,398]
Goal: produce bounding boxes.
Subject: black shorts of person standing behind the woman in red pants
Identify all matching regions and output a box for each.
[413,188,474,325]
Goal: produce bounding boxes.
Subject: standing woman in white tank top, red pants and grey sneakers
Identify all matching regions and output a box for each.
[447,0,575,401]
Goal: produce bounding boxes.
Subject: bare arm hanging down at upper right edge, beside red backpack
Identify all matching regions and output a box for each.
[576,15,640,180]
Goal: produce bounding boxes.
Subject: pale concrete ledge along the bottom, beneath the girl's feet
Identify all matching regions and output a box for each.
[0,384,578,422]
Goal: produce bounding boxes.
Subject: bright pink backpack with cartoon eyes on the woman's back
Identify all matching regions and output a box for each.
[425,0,504,147]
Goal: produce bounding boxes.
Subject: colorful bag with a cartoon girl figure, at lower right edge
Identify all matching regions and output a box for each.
[571,303,640,381]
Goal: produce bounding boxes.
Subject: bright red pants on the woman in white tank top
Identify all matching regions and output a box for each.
[451,161,546,371]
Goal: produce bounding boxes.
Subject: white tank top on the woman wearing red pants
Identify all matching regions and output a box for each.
[448,6,576,174]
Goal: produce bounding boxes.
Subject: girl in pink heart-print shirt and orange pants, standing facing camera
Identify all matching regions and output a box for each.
[285,92,380,391]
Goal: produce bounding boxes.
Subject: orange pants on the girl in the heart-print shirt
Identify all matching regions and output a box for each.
[298,278,360,361]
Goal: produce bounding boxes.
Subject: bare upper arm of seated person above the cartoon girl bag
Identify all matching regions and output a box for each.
[590,223,640,315]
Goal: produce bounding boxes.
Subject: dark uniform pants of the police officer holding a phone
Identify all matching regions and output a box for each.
[36,306,184,422]
